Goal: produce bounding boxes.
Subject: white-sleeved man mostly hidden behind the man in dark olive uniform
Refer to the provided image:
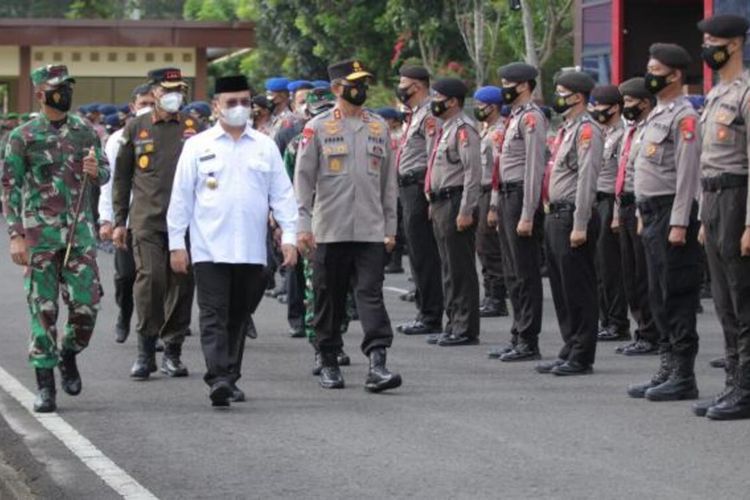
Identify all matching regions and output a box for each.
[99,84,154,344]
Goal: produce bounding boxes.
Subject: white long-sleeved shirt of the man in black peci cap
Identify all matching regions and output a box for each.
[167,124,297,265]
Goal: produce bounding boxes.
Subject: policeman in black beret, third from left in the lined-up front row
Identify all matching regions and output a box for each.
[489,62,547,361]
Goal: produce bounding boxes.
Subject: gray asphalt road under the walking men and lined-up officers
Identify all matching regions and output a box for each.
[0,227,750,500]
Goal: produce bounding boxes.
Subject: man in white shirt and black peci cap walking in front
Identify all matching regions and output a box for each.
[167,76,297,406]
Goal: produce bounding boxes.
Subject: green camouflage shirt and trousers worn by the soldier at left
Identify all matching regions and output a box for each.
[2,114,109,368]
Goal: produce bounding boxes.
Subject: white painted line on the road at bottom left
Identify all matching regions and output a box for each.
[0,368,158,500]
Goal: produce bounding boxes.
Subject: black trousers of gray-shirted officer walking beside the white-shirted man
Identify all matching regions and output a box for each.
[312,242,393,355]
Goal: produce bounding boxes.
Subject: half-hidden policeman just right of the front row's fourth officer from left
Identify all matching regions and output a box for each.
[590,85,630,340]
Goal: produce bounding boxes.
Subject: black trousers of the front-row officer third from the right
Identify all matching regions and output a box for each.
[544,205,599,366]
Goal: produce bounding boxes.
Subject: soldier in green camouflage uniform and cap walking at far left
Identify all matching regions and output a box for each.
[2,65,109,412]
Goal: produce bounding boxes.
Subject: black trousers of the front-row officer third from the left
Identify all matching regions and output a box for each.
[498,189,544,347]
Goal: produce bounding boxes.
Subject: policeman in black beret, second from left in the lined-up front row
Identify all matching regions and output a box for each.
[424,78,482,347]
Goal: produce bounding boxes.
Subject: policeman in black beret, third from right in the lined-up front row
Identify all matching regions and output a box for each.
[537,71,604,376]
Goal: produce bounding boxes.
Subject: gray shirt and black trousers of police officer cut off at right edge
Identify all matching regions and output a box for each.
[701,75,750,388]
